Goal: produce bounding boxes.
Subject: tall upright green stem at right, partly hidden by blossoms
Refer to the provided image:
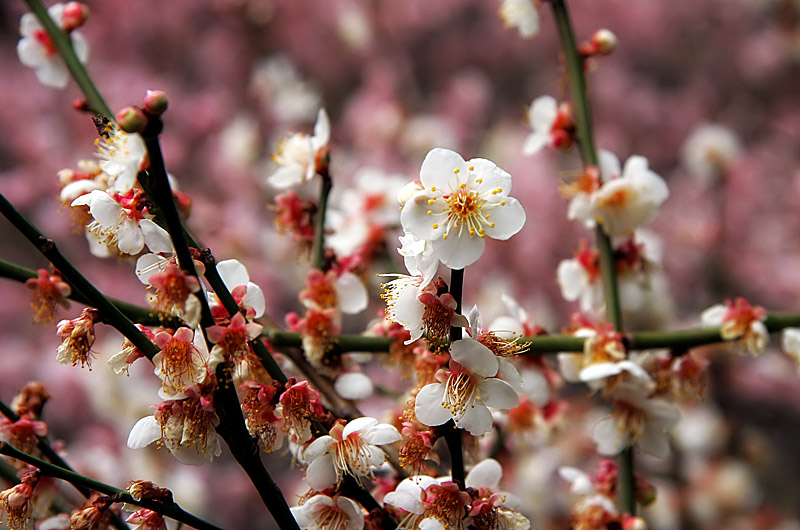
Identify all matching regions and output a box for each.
[550,0,636,514]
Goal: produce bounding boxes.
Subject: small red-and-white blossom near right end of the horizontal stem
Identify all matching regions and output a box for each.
[700,298,769,355]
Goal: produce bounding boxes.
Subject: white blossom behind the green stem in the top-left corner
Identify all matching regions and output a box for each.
[17,4,89,88]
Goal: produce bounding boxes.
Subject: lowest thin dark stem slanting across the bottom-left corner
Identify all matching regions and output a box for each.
[0,442,221,530]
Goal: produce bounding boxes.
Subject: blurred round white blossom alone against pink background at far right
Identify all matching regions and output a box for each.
[681,123,742,183]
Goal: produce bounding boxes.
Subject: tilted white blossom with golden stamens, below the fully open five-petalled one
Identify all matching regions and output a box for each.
[414,339,519,436]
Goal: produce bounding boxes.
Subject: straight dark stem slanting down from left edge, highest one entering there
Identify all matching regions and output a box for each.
[0,194,158,359]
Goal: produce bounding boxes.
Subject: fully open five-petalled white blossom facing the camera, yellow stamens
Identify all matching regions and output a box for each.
[400,148,525,269]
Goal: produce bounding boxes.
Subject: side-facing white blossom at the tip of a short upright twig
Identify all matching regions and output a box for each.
[267,109,331,190]
